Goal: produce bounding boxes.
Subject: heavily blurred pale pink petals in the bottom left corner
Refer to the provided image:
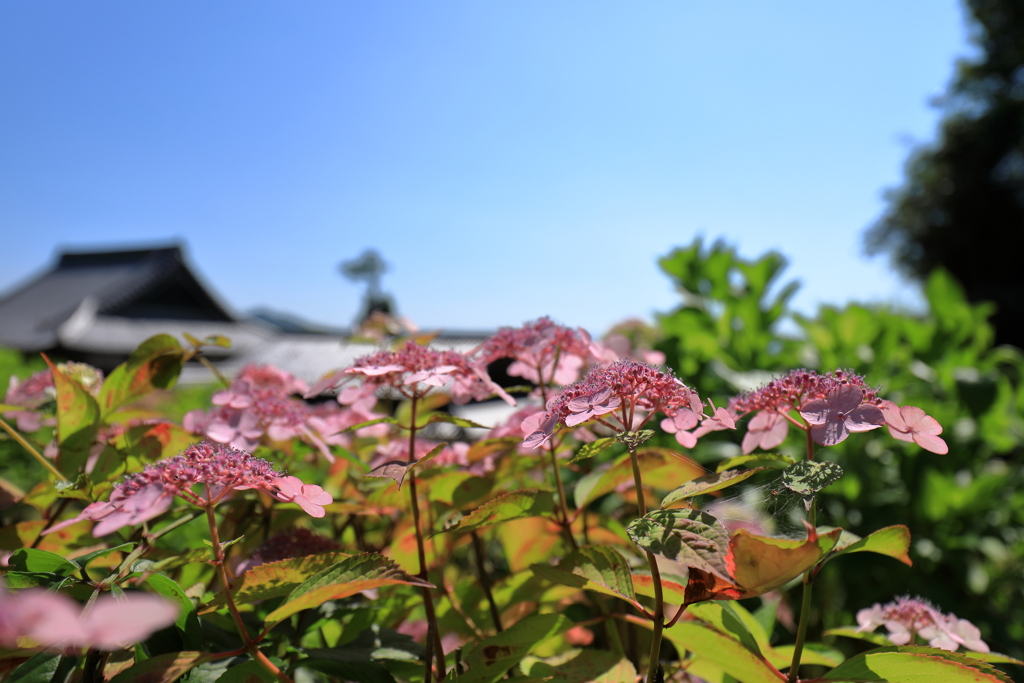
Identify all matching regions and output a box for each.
[0,584,178,650]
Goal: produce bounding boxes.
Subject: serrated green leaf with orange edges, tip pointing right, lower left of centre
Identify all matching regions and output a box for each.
[265,553,430,629]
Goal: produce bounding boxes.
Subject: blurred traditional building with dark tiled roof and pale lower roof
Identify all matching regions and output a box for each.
[0,244,486,383]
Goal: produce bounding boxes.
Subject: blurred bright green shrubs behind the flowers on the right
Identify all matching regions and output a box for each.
[657,240,1024,657]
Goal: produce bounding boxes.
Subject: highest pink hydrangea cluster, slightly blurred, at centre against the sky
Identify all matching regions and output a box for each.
[474,317,602,385]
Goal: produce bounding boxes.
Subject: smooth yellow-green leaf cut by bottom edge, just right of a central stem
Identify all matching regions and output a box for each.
[665,622,785,683]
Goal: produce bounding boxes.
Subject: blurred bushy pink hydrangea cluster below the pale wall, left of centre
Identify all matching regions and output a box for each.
[183,365,373,463]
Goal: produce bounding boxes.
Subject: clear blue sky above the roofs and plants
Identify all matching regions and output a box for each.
[0,0,971,333]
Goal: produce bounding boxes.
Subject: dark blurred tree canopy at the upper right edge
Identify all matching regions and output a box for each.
[866,0,1024,347]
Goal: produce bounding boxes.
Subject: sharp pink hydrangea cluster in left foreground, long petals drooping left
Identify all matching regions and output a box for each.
[46,441,334,537]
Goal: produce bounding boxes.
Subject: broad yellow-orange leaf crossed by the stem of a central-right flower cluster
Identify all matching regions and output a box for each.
[573,449,705,509]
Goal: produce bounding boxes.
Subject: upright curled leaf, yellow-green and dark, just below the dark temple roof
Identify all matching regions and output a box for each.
[97,335,184,419]
